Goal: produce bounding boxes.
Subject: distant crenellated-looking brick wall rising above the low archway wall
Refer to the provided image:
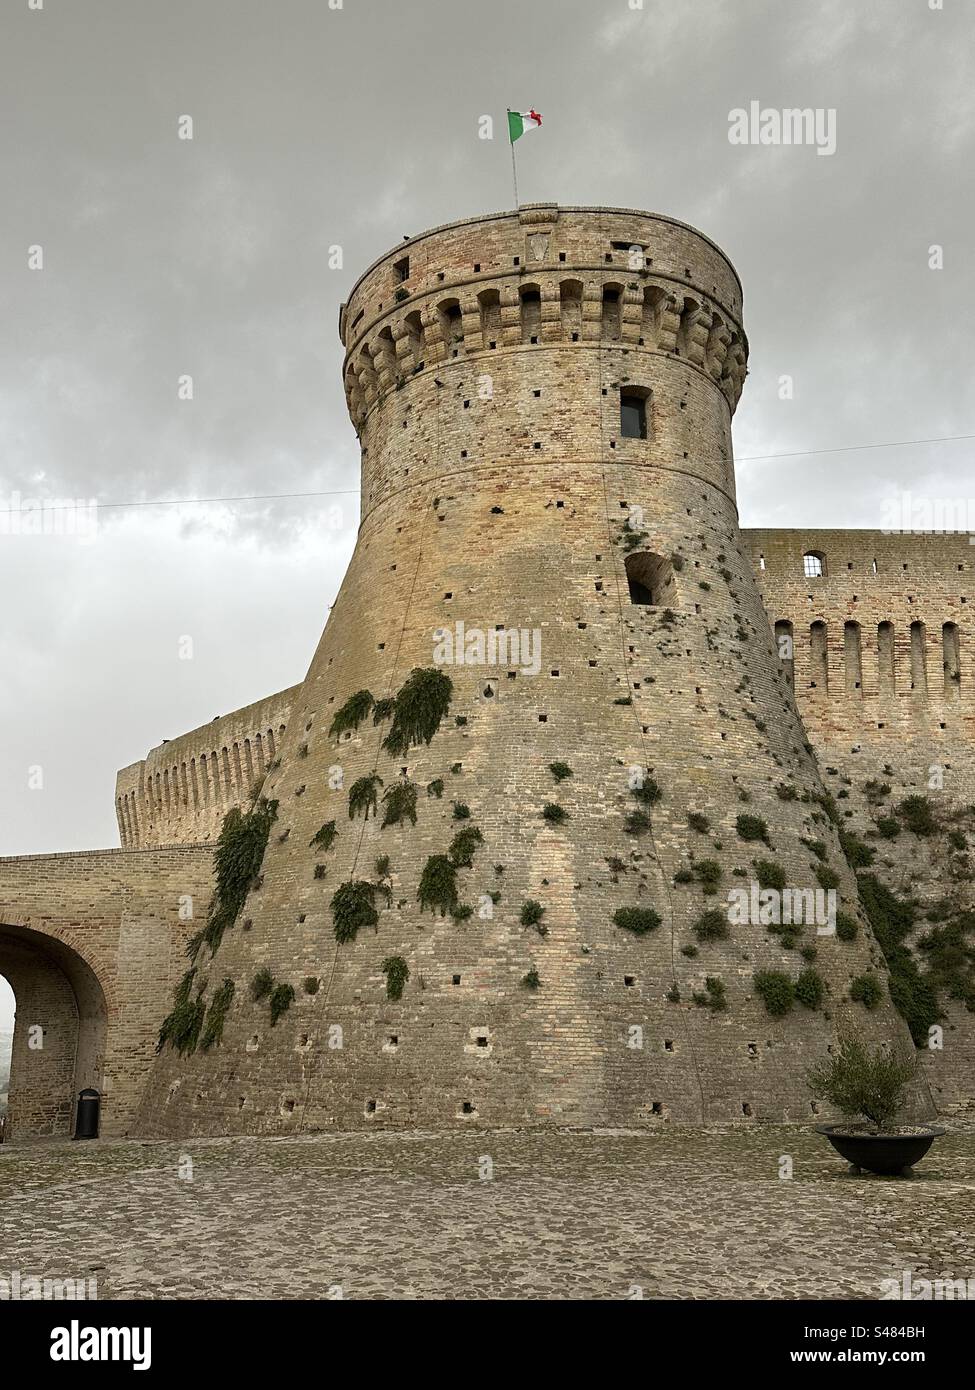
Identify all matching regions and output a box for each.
[115,687,299,848]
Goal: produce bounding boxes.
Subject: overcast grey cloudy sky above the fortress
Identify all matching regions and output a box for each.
[0,0,975,855]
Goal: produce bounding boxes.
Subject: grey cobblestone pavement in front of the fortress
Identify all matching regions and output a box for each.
[0,1127,975,1298]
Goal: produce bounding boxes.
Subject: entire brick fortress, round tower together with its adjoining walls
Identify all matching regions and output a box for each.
[0,204,975,1137]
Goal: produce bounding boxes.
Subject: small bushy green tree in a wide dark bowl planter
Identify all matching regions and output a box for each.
[807,1037,944,1177]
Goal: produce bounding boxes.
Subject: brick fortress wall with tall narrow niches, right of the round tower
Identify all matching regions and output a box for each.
[743,530,975,1111]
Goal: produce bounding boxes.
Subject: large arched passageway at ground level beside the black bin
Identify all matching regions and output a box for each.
[0,923,108,1138]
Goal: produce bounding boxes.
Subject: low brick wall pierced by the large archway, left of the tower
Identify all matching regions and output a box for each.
[0,845,213,1137]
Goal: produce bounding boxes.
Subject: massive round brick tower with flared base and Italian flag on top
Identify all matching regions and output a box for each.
[145,204,923,1133]
